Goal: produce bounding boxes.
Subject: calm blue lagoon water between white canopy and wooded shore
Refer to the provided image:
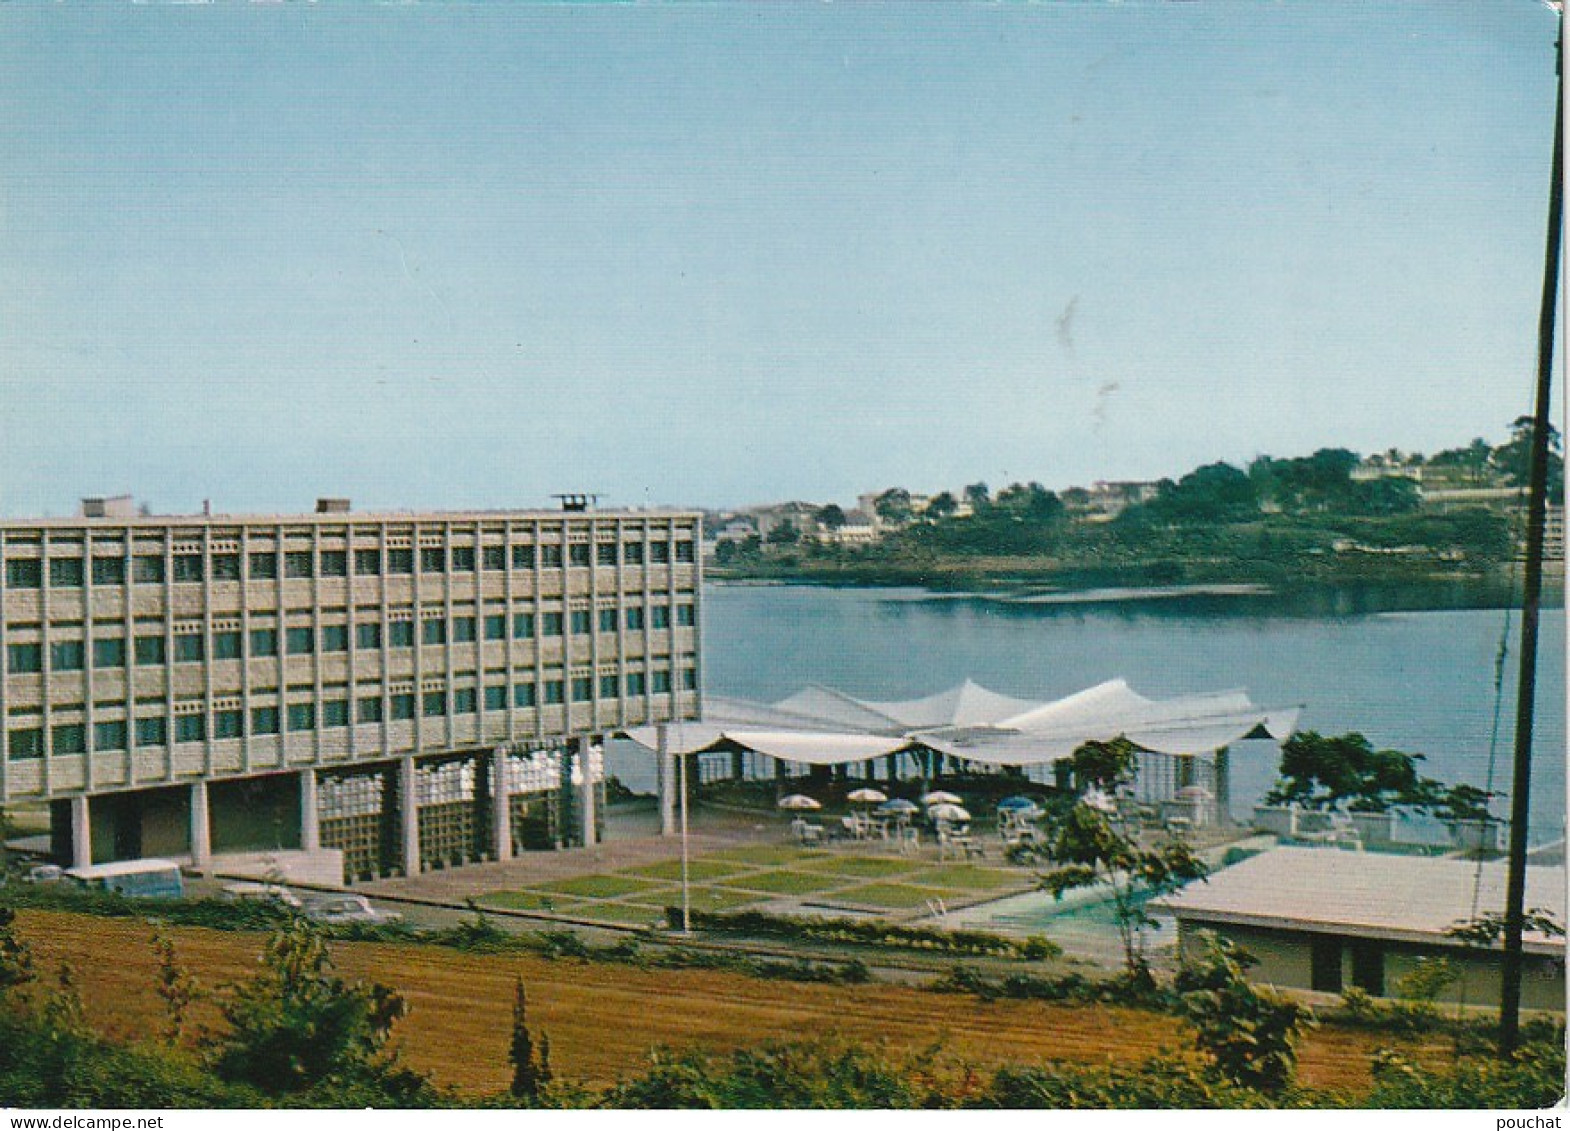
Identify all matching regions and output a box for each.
[693,584,1565,842]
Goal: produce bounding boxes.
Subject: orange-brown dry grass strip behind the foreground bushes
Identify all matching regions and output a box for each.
[19,911,1446,1092]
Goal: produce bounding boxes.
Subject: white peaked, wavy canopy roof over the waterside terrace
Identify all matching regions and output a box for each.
[623,679,1298,767]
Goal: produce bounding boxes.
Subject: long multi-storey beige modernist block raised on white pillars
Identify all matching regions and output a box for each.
[0,496,702,880]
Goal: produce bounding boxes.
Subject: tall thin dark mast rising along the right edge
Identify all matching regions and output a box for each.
[1499,14,1565,1056]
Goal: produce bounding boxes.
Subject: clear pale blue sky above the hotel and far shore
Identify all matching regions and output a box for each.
[0,0,1554,515]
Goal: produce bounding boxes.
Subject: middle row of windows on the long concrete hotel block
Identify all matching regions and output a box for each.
[6,605,697,674]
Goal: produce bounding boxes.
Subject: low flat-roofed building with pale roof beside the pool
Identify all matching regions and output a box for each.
[1156,848,1565,1012]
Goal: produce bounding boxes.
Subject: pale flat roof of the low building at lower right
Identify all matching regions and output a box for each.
[1157,848,1567,955]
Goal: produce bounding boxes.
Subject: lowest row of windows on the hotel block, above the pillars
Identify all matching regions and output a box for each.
[6,668,697,760]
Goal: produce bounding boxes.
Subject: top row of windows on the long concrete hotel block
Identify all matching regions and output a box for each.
[5,542,692,589]
